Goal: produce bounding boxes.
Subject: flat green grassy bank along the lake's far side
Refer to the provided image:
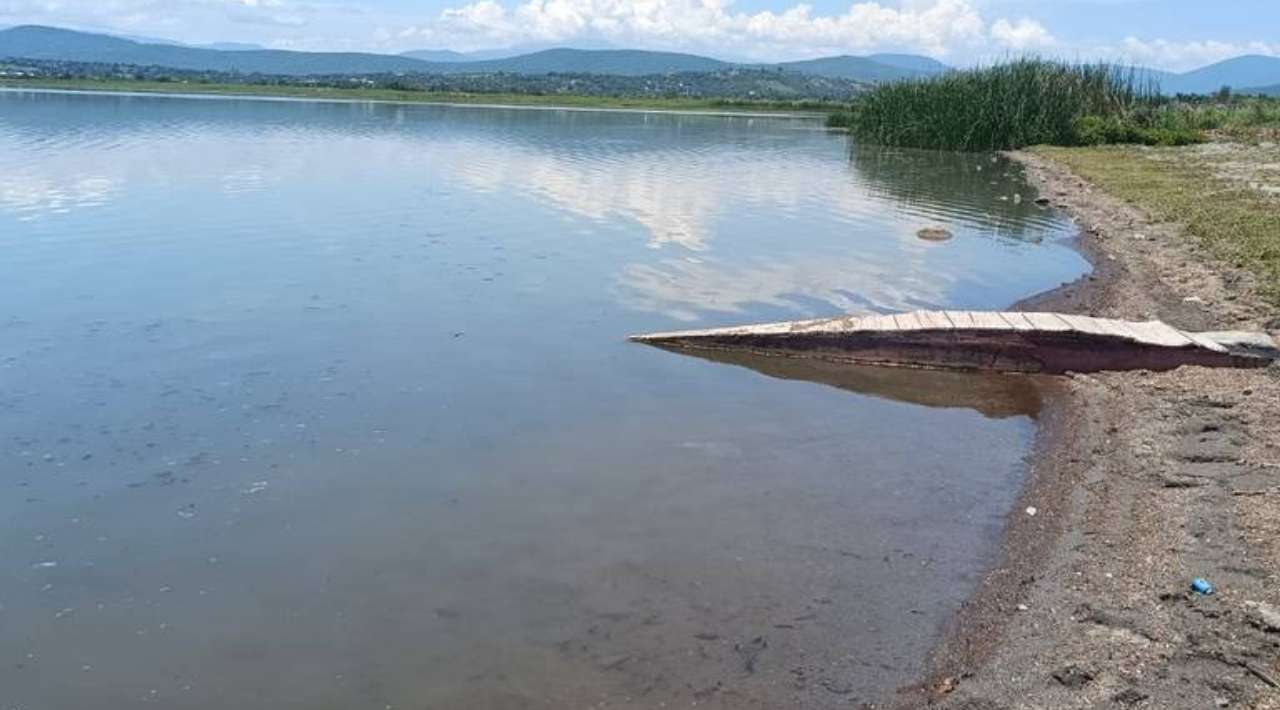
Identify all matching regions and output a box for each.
[0,78,835,114]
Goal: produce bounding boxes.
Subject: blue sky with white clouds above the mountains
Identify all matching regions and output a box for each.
[0,0,1280,70]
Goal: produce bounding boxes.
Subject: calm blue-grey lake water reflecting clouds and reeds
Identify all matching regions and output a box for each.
[0,92,1085,710]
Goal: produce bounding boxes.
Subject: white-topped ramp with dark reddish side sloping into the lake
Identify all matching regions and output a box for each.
[631,311,1280,374]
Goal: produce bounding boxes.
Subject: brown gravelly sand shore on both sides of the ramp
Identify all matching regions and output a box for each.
[897,147,1280,710]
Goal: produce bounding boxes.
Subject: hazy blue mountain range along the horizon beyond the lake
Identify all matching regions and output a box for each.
[0,26,1280,93]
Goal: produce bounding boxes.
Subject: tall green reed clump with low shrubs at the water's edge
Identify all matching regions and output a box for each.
[831,59,1280,151]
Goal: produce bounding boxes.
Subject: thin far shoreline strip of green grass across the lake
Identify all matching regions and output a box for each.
[0,81,827,120]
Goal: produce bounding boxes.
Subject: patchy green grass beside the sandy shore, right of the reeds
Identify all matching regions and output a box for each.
[1034,145,1280,306]
